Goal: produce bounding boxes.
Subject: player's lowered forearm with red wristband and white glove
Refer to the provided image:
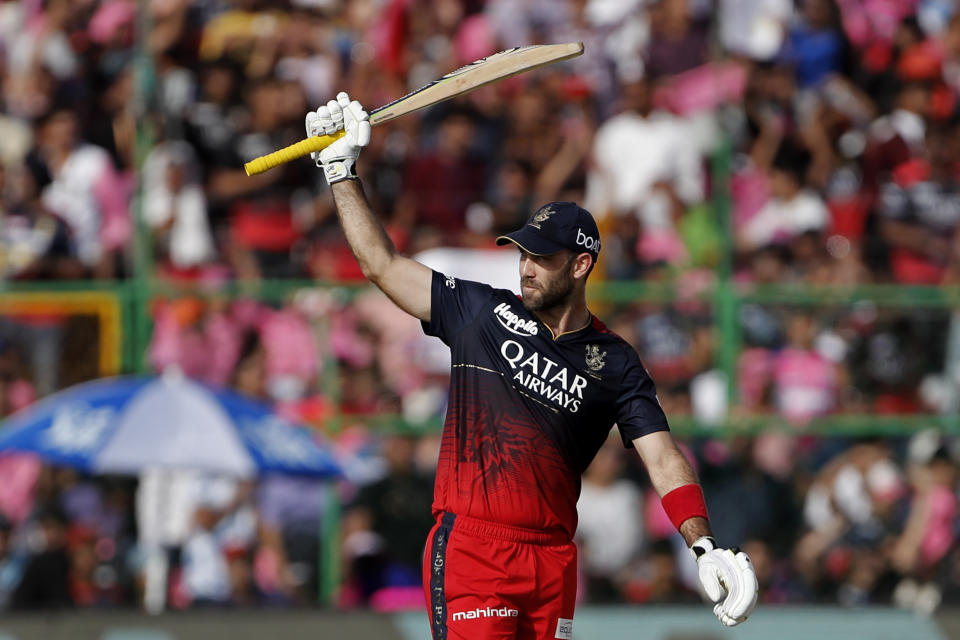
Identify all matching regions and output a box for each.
[633,431,758,627]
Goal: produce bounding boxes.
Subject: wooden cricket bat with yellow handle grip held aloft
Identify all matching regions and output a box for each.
[243,42,583,176]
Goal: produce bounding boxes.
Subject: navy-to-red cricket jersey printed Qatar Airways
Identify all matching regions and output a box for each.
[423,272,669,539]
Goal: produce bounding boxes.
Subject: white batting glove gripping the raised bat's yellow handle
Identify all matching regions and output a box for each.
[306,91,370,184]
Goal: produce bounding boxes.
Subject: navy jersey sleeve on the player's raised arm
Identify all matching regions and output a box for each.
[421,271,496,345]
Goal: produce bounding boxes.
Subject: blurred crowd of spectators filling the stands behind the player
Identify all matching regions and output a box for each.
[0,0,960,612]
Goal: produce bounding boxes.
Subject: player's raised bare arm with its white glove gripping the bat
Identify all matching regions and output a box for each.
[306,92,433,322]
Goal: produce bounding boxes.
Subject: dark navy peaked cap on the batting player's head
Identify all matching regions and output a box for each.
[497,202,600,262]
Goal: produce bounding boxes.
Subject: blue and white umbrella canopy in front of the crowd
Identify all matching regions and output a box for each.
[0,375,340,477]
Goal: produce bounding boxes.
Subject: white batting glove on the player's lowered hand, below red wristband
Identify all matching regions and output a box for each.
[690,536,759,627]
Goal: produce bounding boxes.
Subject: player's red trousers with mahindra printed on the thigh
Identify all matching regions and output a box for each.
[423,513,577,640]
